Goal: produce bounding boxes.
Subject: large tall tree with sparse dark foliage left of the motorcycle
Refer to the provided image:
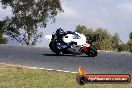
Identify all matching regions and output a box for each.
[1,0,63,45]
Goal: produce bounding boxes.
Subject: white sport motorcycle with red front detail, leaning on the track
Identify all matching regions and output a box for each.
[45,28,98,57]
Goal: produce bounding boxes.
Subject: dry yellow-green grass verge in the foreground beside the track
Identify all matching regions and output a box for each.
[0,65,132,88]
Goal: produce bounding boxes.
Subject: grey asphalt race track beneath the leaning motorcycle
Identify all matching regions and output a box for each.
[0,45,132,75]
